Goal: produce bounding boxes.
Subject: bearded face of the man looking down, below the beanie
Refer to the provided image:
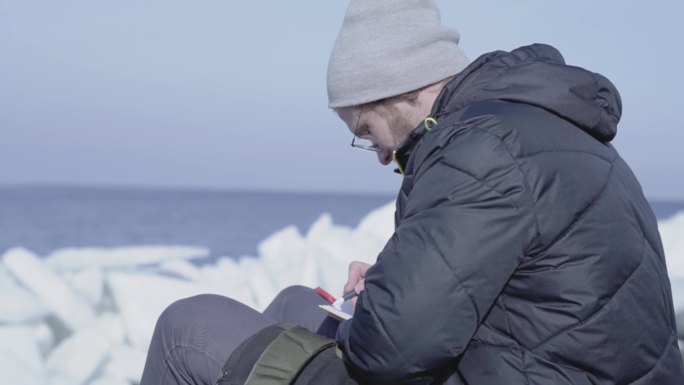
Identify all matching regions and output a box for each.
[335,98,422,165]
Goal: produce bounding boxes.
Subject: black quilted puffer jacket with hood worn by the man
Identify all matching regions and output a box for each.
[338,45,684,385]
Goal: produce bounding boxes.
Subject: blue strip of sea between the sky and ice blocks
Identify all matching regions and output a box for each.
[0,186,392,259]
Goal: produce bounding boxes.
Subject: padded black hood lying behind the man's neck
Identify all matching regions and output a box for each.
[432,44,622,142]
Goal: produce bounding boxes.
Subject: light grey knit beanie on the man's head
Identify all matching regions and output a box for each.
[328,0,468,108]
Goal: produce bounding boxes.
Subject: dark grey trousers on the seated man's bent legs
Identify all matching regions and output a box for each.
[140,286,338,385]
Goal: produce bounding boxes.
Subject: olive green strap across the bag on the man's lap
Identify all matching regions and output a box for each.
[245,324,335,385]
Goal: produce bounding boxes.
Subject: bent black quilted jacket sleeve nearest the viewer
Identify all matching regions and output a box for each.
[337,152,536,384]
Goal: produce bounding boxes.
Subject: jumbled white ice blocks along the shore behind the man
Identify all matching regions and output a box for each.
[0,204,684,385]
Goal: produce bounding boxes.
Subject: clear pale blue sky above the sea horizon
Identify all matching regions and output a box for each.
[0,0,684,200]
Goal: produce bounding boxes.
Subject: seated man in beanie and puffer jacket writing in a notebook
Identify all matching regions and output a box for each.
[143,0,684,385]
